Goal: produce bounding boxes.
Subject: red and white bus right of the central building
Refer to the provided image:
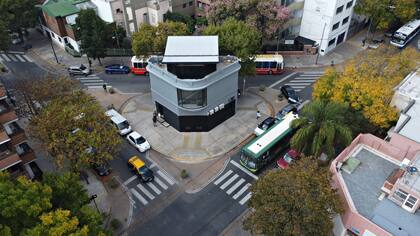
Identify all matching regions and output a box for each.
[254,54,284,75]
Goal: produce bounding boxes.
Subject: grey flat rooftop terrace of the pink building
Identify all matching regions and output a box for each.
[340,146,420,236]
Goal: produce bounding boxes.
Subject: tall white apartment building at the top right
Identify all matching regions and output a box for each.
[299,0,356,55]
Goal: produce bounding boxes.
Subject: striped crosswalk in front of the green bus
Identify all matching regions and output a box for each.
[213,170,252,205]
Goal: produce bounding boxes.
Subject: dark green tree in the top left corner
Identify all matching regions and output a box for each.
[0,0,38,38]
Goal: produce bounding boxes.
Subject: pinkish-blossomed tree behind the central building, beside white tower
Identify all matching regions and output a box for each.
[208,0,289,39]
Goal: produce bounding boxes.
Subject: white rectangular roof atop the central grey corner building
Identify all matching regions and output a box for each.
[162,36,219,63]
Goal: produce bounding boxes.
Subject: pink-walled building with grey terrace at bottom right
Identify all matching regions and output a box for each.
[330,134,420,236]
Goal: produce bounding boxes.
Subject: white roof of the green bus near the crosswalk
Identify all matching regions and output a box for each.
[248,113,298,154]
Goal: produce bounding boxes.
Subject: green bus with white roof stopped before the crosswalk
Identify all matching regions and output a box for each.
[240,112,298,173]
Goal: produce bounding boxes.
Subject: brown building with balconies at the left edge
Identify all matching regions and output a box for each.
[0,85,40,179]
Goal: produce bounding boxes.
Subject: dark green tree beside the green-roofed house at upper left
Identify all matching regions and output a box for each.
[75,9,110,64]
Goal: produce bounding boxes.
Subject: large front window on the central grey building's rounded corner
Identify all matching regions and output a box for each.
[177,89,207,108]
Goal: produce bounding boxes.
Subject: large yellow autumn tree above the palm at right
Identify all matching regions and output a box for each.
[312,47,420,128]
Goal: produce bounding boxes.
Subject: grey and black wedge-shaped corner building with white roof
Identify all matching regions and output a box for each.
[147,36,241,131]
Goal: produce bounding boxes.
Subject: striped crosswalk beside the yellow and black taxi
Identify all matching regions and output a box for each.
[124,170,175,207]
